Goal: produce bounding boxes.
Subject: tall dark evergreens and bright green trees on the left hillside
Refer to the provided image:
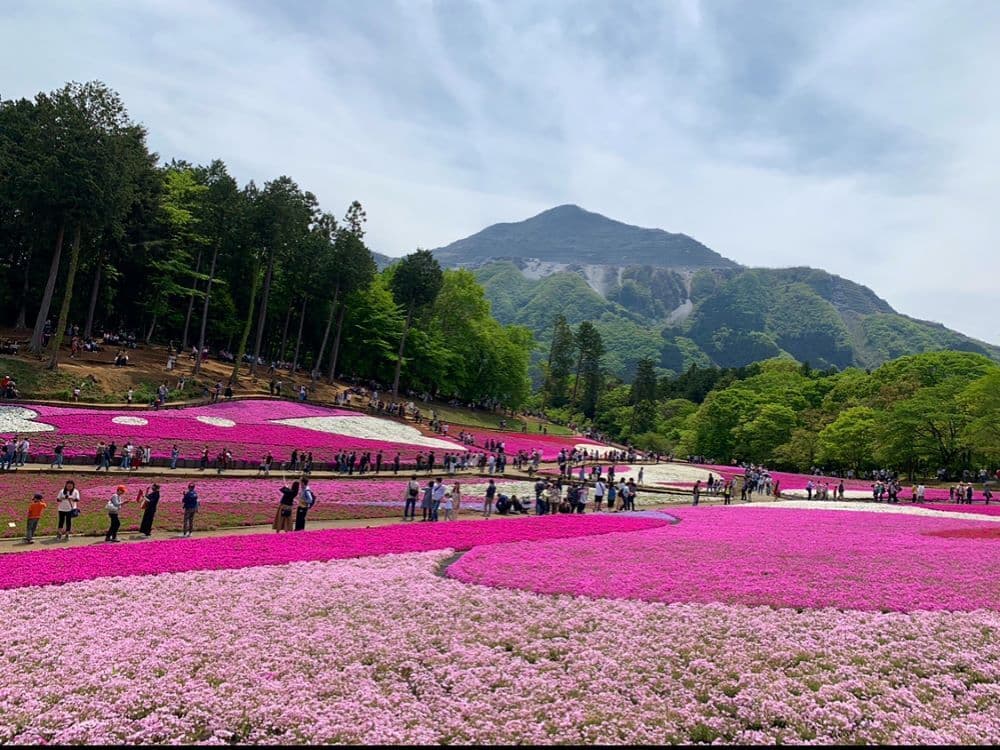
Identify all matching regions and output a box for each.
[0,82,534,407]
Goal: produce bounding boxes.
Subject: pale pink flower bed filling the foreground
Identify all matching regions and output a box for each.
[0,551,1000,744]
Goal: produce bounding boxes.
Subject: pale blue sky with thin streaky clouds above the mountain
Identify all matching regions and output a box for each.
[0,0,1000,344]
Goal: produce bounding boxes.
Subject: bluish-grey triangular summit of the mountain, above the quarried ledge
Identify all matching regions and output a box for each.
[434,203,737,268]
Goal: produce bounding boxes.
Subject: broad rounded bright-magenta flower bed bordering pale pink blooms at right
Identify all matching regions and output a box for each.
[448,507,1000,611]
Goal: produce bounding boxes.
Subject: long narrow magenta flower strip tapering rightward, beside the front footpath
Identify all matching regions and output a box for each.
[0,515,667,589]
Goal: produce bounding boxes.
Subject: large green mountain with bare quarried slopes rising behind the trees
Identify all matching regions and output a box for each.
[433,206,1000,379]
